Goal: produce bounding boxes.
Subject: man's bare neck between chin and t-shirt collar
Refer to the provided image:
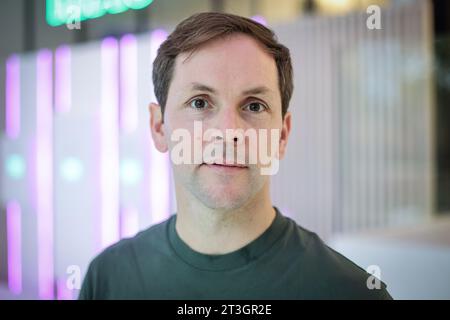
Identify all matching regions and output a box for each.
[175,184,275,254]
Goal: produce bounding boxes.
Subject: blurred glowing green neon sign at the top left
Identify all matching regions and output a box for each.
[46,0,153,27]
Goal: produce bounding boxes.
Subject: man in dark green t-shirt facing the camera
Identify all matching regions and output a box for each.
[80,13,390,299]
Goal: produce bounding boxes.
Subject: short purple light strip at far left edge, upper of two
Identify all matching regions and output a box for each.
[5,55,20,139]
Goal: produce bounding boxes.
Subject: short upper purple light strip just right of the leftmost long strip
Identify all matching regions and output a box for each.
[55,45,72,113]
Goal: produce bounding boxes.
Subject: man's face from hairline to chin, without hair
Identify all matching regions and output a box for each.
[151,34,290,210]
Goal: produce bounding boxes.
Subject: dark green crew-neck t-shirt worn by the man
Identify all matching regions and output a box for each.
[79,210,391,299]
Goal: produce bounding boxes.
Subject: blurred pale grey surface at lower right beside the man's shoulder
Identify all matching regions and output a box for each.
[329,217,450,299]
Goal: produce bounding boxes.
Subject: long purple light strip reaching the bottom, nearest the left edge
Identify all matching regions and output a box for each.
[35,49,54,299]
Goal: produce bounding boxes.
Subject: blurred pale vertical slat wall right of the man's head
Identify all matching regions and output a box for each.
[272,1,433,239]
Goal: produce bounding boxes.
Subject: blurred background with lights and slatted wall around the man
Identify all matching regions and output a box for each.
[0,0,450,299]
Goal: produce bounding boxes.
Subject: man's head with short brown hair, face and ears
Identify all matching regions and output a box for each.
[150,13,293,210]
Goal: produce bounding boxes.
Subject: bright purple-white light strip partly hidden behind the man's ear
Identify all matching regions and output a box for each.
[149,29,171,223]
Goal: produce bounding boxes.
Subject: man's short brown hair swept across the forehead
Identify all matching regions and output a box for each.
[153,12,293,117]
